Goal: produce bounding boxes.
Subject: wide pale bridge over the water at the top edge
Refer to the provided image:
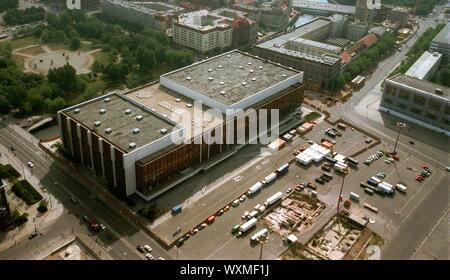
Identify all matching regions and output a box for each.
[293,0,356,15]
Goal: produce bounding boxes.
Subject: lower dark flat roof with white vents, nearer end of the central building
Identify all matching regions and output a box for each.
[63,90,176,152]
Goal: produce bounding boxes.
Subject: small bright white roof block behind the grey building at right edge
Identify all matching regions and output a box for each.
[405,51,442,80]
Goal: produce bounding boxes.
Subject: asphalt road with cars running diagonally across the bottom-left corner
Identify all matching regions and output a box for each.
[0,125,170,259]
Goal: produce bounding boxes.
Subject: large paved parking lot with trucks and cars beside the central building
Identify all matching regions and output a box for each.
[152,118,445,259]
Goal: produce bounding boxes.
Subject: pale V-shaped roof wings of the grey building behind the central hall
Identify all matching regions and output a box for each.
[257,18,340,65]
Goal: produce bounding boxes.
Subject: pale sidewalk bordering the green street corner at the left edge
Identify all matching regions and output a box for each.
[0,145,64,252]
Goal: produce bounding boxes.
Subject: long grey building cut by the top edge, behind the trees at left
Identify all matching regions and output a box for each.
[100,0,183,32]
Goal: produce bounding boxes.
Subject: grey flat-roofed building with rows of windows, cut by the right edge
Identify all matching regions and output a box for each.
[380,74,450,135]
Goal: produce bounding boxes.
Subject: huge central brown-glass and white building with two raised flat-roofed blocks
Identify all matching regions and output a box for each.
[58,51,304,200]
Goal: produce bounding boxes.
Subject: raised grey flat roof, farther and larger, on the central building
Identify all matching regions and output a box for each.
[162,50,299,105]
